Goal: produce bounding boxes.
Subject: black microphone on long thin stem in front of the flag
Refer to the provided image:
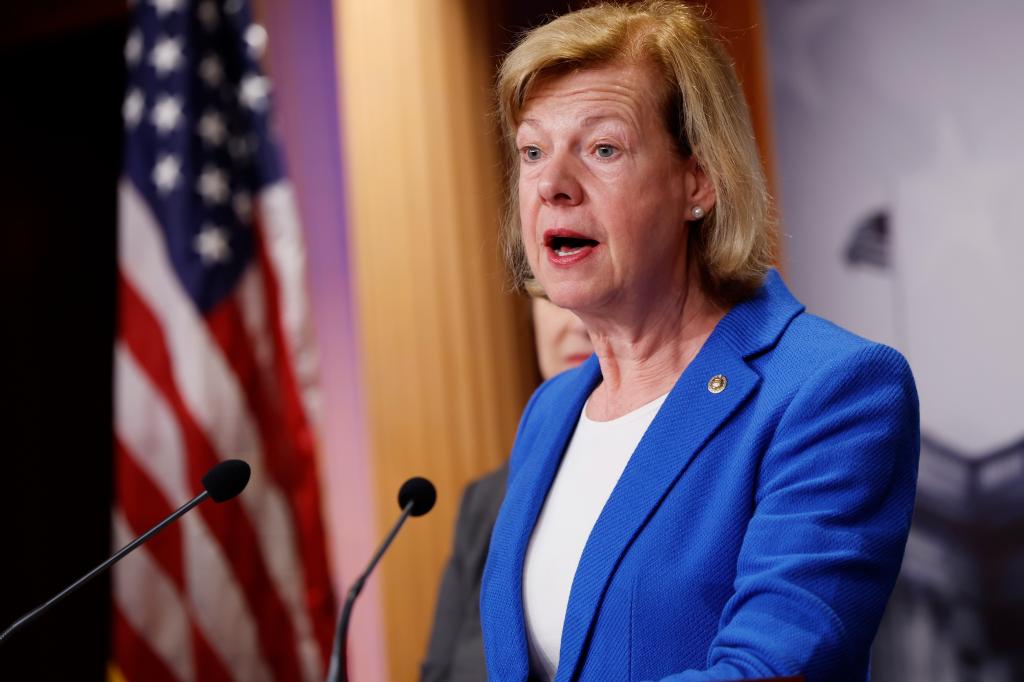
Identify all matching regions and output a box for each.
[0,460,251,644]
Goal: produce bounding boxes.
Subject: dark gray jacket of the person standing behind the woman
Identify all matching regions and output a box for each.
[420,464,509,682]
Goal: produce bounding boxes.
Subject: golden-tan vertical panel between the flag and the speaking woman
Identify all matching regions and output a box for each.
[334,0,537,680]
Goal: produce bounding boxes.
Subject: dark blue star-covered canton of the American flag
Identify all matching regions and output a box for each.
[123,0,283,312]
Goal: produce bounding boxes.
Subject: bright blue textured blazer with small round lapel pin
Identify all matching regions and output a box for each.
[480,271,920,682]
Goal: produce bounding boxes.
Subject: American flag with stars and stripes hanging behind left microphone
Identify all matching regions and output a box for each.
[113,0,335,682]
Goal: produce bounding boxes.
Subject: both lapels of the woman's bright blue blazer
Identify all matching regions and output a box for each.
[488,270,803,681]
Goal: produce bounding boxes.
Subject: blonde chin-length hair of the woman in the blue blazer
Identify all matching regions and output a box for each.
[496,0,775,303]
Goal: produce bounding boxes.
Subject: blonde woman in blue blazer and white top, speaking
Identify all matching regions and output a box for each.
[481,2,920,682]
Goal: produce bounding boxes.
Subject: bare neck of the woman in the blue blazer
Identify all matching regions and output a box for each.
[584,270,727,421]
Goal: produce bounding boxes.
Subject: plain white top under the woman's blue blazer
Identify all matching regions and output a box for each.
[522,393,668,680]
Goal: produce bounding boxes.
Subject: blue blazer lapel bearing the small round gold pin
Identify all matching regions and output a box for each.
[557,271,802,681]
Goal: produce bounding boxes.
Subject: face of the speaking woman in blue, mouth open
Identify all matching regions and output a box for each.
[516,63,714,315]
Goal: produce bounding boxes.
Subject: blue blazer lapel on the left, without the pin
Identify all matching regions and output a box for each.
[484,355,601,680]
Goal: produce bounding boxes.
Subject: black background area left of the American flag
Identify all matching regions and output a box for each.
[0,2,127,680]
